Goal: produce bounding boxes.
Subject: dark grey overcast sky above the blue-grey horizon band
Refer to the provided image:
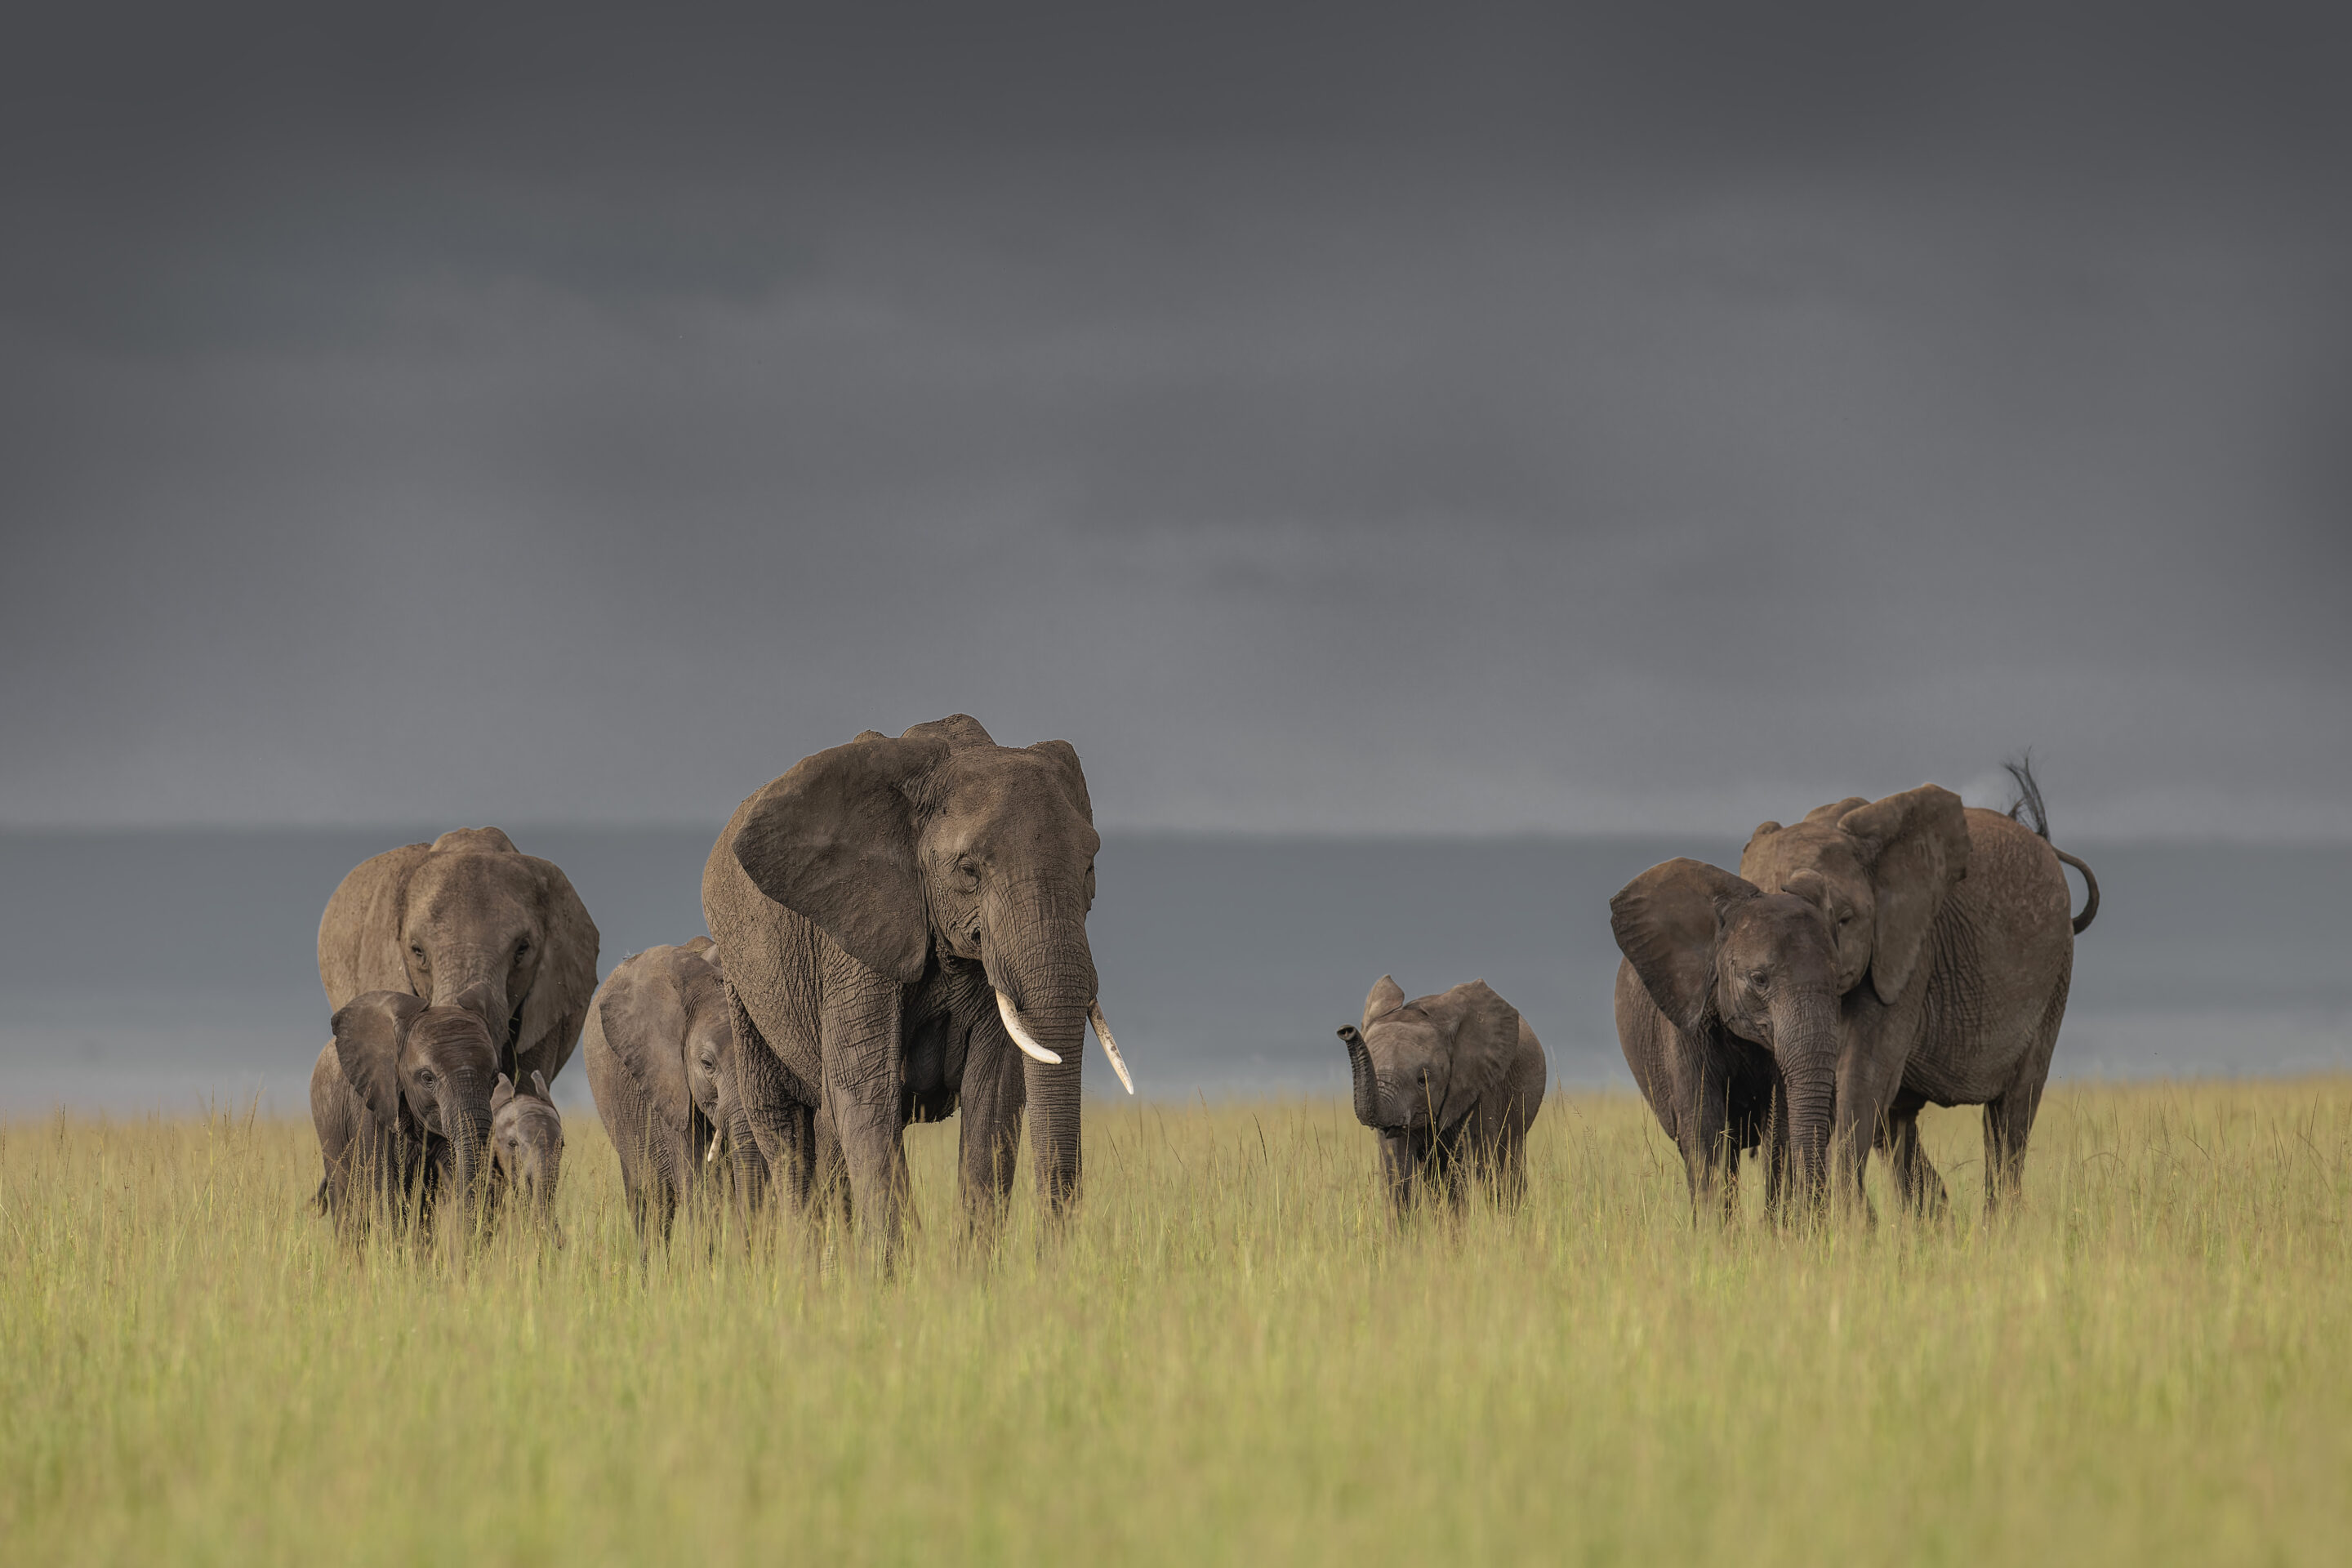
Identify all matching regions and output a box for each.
[0,0,2352,840]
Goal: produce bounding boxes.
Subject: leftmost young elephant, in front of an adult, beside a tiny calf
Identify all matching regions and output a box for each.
[310,990,499,1223]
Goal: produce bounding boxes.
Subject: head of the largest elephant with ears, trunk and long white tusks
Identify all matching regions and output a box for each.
[734,715,1127,1204]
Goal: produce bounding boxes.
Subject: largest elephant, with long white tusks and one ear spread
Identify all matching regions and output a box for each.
[703,715,1134,1255]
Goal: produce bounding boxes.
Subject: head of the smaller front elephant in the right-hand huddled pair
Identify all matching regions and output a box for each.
[1609,861,1842,1196]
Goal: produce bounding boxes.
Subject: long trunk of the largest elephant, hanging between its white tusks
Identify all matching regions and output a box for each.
[981,881,1096,1213]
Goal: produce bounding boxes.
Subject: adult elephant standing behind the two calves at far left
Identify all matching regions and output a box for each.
[318,827,598,1084]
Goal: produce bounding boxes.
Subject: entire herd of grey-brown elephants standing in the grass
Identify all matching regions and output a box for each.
[310,715,2098,1255]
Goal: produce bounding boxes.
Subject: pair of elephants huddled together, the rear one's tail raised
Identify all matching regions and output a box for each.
[1611,776,2098,1213]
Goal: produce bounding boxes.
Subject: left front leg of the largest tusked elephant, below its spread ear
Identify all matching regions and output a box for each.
[823,952,906,1269]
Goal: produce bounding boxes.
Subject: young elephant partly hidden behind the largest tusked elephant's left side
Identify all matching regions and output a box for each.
[581,936,847,1263]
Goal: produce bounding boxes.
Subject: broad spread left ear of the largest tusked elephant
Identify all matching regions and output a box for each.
[734,737,950,985]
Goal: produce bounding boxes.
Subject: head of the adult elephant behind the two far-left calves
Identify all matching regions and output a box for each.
[393,827,598,1072]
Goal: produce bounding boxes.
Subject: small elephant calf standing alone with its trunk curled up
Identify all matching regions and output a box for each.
[1339,976,1543,1213]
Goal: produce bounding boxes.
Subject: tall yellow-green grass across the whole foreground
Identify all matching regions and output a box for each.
[0,1079,2352,1566]
